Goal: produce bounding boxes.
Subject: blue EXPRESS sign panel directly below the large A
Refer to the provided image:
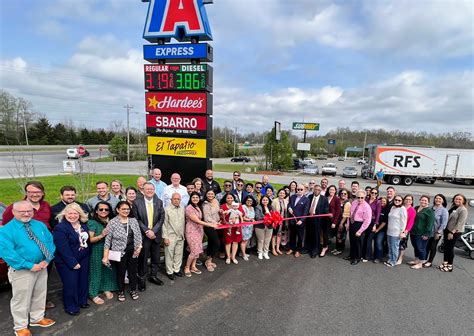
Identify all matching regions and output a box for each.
[143,43,212,62]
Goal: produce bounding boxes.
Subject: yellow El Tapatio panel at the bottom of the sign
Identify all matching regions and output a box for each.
[148,136,207,159]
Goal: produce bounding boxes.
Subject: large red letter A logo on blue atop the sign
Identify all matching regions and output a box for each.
[143,0,212,42]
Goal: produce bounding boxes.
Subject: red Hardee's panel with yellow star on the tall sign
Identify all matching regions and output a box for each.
[145,91,212,114]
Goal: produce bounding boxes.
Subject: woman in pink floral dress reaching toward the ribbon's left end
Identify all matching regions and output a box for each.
[184,192,217,277]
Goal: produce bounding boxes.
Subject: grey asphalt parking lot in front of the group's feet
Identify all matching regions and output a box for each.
[0,243,474,335]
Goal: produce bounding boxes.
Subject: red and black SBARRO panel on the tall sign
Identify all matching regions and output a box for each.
[146,114,211,137]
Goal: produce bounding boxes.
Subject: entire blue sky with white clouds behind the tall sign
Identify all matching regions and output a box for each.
[0,0,474,134]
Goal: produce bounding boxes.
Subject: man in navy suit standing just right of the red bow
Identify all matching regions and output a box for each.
[286,184,309,258]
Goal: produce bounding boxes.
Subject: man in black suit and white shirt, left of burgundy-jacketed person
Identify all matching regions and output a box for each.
[305,184,329,258]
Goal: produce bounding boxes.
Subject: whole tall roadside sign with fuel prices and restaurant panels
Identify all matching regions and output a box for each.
[143,0,213,183]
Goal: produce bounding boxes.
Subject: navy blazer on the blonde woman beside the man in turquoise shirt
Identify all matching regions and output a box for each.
[53,219,91,269]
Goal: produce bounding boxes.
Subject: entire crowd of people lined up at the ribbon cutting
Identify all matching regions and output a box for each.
[0,168,467,335]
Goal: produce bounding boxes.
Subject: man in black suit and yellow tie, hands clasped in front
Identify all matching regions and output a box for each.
[133,182,165,292]
